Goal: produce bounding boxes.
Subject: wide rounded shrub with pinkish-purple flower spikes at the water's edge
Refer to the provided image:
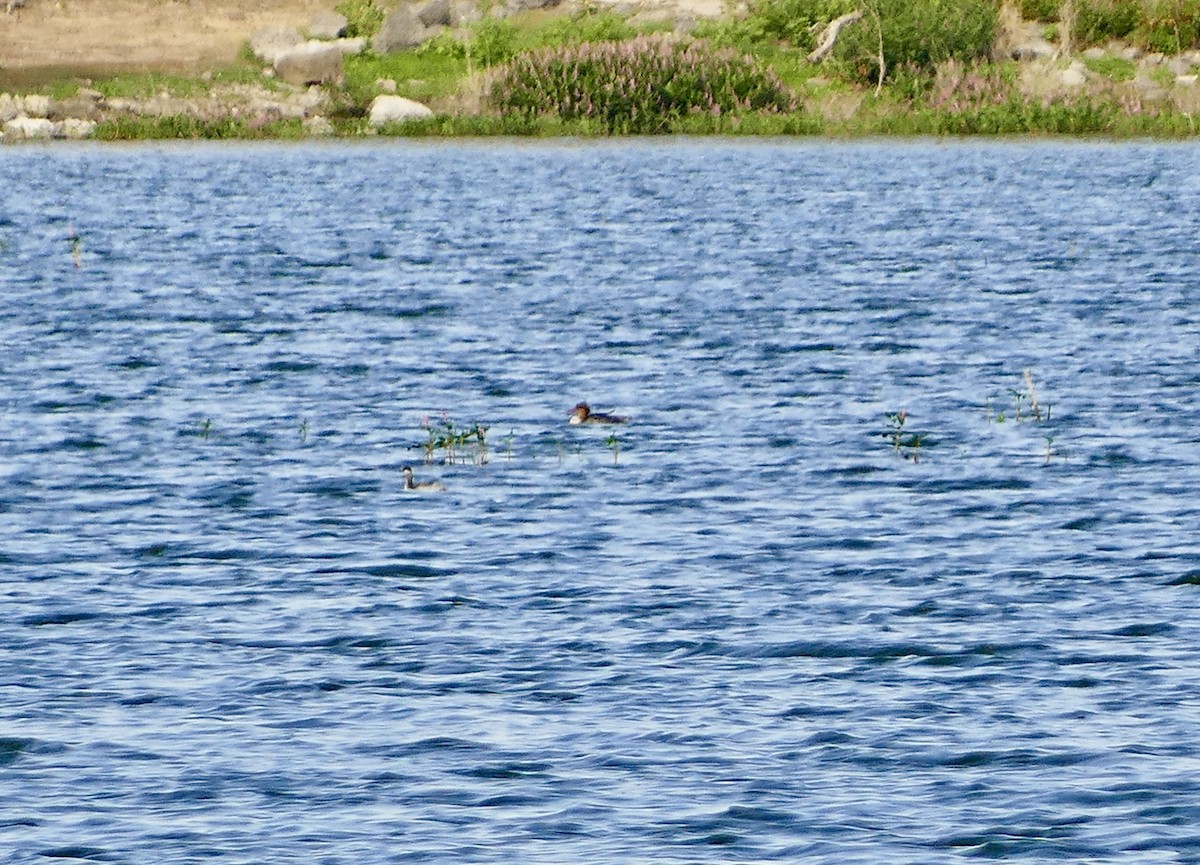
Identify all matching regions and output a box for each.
[491,36,797,134]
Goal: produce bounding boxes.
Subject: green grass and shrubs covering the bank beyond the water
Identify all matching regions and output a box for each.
[11,0,1200,140]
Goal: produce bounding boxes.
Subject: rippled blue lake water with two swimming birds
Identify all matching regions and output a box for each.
[0,140,1200,865]
